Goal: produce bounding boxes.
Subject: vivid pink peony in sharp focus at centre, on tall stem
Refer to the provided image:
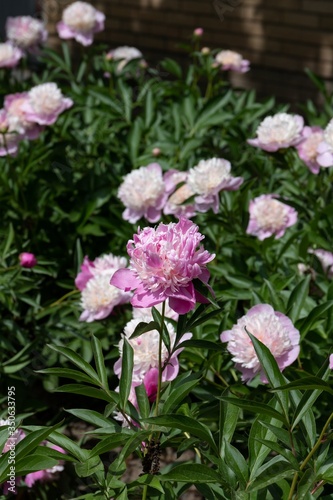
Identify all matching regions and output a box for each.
[111,218,215,314]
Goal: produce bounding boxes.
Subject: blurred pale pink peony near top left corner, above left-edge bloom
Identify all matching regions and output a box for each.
[6,16,47,52]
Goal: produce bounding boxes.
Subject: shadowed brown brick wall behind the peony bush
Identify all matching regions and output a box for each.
[42,0,333,102]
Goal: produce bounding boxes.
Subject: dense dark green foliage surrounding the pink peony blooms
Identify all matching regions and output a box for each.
[0,8,333,500]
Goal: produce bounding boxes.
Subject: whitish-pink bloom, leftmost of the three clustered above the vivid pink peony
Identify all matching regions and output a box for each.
[118,163,167,224]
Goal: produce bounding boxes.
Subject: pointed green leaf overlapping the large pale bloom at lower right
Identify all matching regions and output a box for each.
[245,328,289,422]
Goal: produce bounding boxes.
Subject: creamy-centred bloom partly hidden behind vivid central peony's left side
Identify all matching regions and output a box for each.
[75,254,131,323]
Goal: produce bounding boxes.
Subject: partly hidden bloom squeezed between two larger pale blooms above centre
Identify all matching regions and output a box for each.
[163,169,196,219]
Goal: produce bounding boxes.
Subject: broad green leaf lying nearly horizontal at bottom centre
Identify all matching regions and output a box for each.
[158,464,221,484]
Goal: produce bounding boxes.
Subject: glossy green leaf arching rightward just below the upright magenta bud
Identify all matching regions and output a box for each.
[144,415,218,452]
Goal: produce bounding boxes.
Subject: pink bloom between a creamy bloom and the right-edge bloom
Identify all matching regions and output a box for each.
[295,127,324,174]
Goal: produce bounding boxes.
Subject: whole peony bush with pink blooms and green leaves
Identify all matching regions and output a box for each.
[0,2,333,500]
